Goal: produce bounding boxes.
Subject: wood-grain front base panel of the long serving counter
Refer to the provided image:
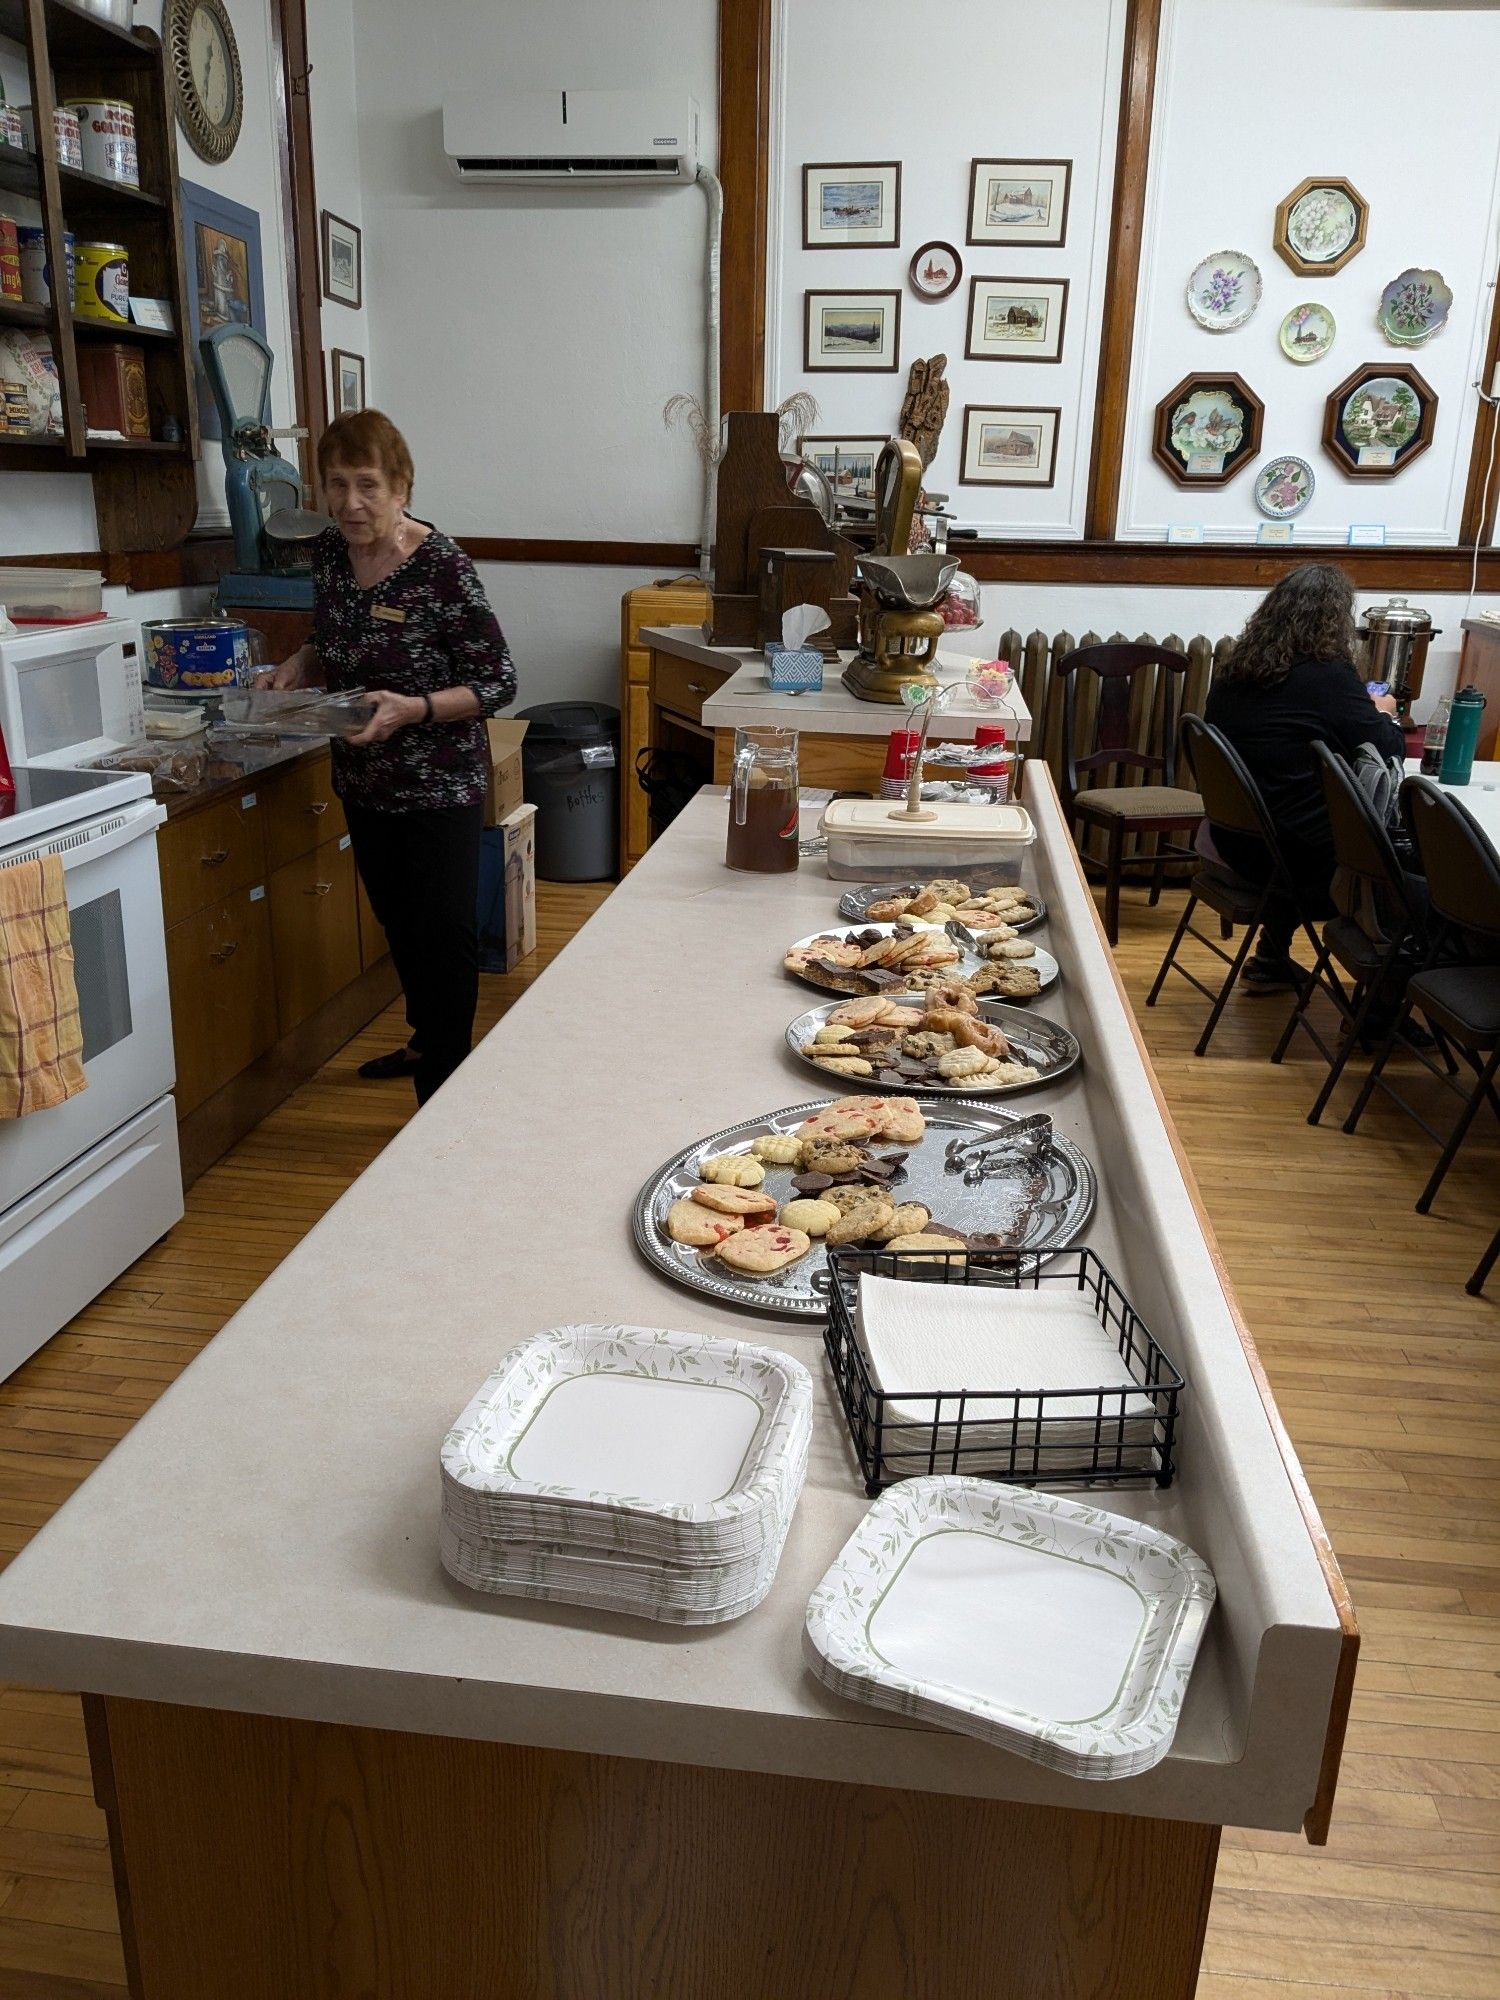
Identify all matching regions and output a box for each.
[84,1696,1218,2000]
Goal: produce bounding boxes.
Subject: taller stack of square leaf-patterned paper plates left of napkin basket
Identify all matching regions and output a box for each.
[440,1326,812,1624]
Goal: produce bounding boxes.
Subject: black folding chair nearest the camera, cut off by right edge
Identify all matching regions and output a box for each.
[1344,778,1500,1216]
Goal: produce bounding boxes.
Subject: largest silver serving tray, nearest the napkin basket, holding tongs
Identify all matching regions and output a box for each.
[630,1092,1098,1320]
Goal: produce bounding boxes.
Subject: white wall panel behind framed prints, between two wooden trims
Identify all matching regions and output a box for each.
[766,0,1124,538]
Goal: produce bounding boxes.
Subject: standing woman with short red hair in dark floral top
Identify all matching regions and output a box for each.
[262,410,516,1104]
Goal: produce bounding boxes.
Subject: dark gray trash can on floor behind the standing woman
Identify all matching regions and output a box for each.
[516,702,620,882]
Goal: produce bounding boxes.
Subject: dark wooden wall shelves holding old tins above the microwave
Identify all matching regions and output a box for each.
[0,0,198,550]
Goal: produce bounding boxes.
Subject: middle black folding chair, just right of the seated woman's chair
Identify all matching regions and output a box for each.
[1272,742,1426,1124]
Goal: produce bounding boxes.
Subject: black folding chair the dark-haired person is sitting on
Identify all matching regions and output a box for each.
[1146,716,1350,1064]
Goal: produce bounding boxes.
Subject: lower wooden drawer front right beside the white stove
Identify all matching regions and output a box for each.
[166,884,276,1118]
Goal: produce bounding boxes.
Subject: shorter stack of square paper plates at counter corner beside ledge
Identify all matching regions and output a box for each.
[802,1478,1214,1778]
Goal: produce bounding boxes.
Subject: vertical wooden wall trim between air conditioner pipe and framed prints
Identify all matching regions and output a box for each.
[720,0,774,410]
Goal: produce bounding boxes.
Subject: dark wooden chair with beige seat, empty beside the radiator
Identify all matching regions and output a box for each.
[1058,644,1204,944]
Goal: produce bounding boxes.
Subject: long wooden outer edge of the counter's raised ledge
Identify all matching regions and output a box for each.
[1024,758,1360,1846]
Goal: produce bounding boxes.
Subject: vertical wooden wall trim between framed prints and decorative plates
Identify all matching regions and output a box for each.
[1084,0,1162,542]
